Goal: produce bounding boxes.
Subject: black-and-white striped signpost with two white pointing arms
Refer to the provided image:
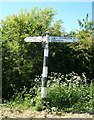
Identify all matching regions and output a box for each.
[24,33,78,105]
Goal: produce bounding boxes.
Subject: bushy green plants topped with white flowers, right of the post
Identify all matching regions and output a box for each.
[47,72,94,112]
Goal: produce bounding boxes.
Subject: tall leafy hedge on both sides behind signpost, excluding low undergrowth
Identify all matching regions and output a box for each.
[1,8,94,106]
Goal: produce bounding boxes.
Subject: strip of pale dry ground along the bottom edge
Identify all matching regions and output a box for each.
[0,108,94,119]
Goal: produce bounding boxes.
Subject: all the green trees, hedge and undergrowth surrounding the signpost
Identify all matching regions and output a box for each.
[1,8,94,112]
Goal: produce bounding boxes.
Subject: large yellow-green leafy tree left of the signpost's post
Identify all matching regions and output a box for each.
[2,8,63,99]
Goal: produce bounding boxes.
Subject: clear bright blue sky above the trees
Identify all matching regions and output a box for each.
[0,2,92,32]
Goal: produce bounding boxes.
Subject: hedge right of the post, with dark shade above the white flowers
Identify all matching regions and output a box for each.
[49,15,94,79]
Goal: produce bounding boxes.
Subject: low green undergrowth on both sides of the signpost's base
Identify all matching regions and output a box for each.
[2,72,94,113]
